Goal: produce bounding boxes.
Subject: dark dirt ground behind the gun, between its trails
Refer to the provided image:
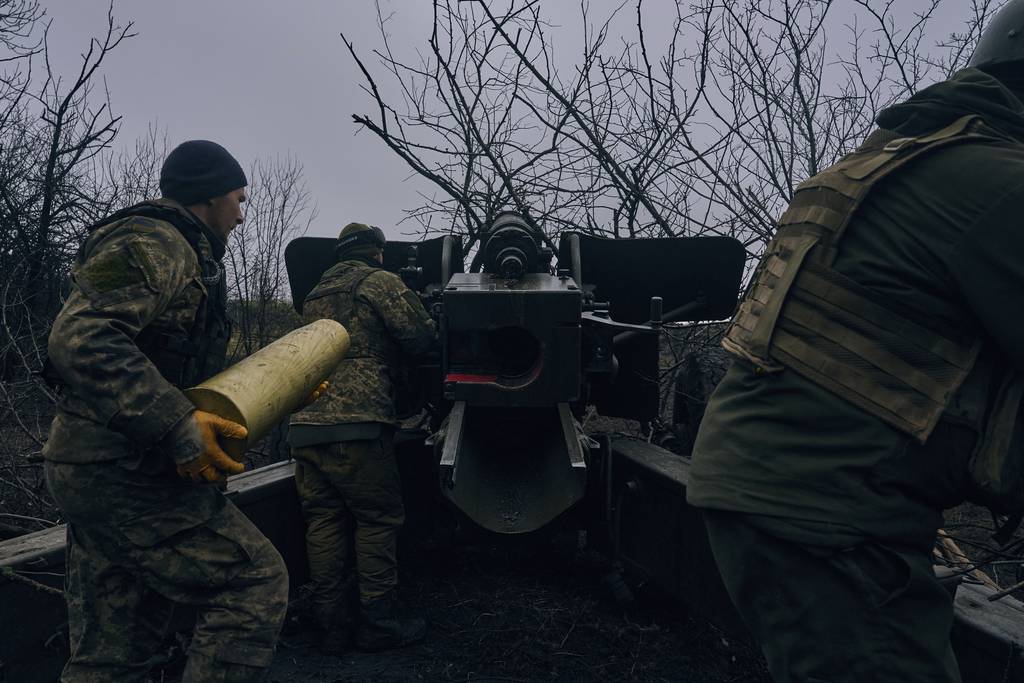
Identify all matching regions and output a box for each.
[269,537,770,683]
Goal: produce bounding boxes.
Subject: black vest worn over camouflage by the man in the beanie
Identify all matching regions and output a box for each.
[87,202,231,388]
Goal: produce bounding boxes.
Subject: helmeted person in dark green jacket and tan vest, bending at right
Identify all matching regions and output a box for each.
[687,0,1024,683]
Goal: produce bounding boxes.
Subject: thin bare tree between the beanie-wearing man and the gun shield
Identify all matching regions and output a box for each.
[226,156,316,356]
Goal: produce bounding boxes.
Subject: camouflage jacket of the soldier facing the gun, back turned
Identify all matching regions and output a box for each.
[292,260,436,425]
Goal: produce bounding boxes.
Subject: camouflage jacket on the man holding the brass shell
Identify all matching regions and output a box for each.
[43,200,221,463]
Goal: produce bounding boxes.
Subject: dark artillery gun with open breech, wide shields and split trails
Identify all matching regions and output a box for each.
[0,214,1024,683]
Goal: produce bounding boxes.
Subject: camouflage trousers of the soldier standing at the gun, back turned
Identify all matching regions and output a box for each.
[292,431,406,628]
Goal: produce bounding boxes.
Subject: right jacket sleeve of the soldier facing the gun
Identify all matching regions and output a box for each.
[359,270,437,355]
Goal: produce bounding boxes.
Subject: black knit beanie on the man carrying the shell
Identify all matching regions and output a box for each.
[160,140,249,206]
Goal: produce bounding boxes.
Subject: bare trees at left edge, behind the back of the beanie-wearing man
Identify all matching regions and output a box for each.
[0,0,140,528]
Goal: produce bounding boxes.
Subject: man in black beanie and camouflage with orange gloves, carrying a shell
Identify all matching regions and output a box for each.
[43,140,288,683]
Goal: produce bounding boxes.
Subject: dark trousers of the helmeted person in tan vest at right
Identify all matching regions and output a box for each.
[703,510,961,683]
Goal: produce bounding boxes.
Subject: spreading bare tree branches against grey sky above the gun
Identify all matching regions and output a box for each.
[343,0,999,264]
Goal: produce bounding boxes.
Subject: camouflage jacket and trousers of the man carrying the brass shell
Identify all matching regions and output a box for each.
[43,200,288,683]
